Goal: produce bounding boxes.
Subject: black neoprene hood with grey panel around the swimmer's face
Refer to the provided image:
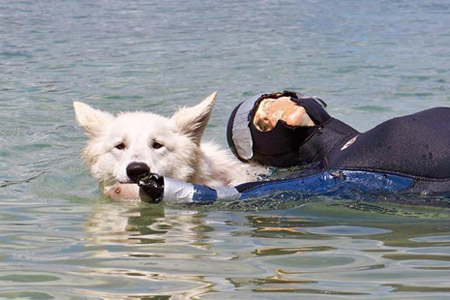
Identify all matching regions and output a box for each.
[227,91,331,167]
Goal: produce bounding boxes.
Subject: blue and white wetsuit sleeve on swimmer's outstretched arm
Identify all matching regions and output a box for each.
[156,170,414,204]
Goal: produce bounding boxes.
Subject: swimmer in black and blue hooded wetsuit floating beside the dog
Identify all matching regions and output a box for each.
[138,91,450,202]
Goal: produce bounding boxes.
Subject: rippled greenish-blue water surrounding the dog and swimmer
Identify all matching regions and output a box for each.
[0,0,450,299]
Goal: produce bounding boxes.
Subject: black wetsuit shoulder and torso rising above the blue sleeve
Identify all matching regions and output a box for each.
[327,107,450,179]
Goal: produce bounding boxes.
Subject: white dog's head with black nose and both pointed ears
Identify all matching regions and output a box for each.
[73,93,216,186]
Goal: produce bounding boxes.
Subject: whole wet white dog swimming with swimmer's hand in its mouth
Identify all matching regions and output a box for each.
[73,93,265,199]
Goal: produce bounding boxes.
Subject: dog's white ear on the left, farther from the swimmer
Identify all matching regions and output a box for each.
[73,101,114,137]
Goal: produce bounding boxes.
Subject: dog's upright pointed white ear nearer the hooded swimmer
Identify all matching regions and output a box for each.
[171,92,217,144]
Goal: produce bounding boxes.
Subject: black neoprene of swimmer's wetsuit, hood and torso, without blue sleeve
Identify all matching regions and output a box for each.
[229,92,450,192]
